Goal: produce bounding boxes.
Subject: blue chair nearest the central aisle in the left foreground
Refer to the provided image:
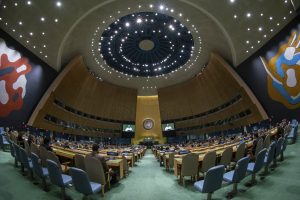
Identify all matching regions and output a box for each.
[69,167,101,196]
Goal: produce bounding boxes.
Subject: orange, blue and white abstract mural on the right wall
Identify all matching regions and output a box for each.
[260,32,300,109]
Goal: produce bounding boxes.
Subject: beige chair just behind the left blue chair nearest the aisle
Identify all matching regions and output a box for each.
[84,156,110,195]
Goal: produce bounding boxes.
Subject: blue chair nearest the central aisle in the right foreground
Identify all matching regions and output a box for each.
[194,165,225,200]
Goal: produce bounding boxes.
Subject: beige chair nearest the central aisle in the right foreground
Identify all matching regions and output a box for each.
[180,153,199,185]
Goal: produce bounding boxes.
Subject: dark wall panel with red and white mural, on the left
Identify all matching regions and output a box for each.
[0,29,57,126]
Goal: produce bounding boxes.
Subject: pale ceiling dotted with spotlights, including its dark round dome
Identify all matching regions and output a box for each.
[0,0,300,95]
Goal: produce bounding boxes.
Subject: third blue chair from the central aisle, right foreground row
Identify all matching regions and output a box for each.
[247,148,267,186]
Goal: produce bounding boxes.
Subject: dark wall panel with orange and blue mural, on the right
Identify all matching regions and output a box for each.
[237,16,300,121]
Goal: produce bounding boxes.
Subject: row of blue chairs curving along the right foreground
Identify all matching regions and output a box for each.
[194,136,287,199]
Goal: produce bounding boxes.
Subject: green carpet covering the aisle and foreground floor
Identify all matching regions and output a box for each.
[0,130,300,200]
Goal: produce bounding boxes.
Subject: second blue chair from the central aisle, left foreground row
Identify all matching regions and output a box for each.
[46,159,72,199]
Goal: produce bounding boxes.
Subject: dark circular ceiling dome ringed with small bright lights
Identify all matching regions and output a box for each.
[91,4,202,82]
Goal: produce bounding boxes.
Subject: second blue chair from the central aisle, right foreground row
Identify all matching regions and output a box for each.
[223,156,250,197]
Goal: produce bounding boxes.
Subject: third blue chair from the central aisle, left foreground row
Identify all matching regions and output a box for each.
[31,153,49,191]
